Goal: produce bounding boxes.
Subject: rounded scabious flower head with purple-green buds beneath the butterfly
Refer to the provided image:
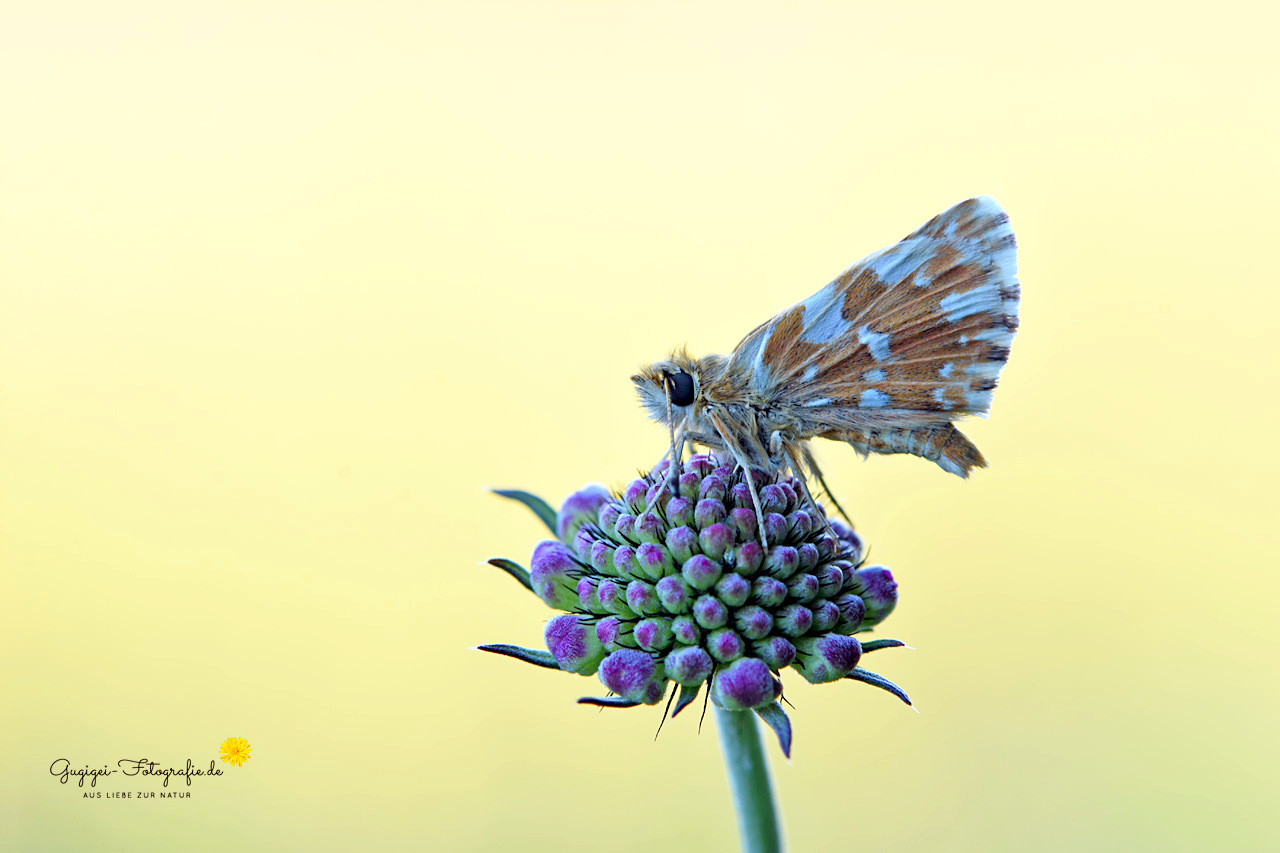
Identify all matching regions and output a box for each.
[481,455,906,749]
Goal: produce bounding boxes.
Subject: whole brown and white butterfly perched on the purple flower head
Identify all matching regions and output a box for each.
[631,196,1019,544]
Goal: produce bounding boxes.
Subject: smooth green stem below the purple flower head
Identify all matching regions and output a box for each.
[716,708,782,853]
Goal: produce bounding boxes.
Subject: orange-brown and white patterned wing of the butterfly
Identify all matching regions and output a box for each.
[730,196,1019,427]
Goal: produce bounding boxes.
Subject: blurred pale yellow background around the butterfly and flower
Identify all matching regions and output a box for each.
[0,0,1280,852]
